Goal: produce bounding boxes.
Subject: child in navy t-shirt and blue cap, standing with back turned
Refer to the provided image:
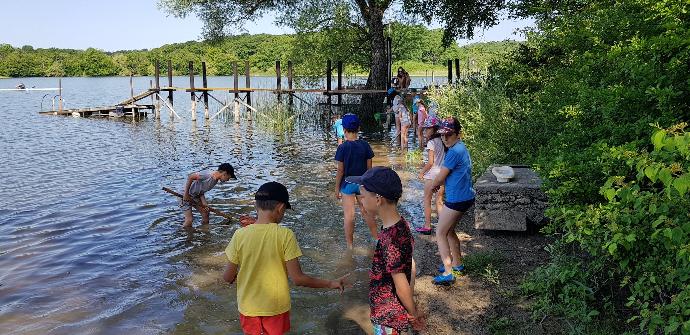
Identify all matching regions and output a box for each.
[335,113,377,248]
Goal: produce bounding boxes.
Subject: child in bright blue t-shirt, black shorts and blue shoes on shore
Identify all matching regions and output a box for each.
[432,118,474,285]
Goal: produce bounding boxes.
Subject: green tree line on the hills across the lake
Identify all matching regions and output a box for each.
[0,24,518,77]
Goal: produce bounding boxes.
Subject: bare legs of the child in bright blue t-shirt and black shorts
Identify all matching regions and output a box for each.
[436,206,463,275]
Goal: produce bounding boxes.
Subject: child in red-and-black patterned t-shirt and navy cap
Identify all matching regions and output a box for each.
[347,166,424,335]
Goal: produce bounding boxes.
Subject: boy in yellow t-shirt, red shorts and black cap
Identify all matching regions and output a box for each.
[223,182,345,335]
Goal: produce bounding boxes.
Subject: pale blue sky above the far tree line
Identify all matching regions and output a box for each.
[0,0,532,51]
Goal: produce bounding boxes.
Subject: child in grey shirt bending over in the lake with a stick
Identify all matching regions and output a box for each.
[180,163,237,228]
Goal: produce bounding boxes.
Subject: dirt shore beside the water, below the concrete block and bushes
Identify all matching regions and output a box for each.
[329,211,558,335]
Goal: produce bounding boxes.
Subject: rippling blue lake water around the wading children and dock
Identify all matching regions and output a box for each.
[0,77,430,334]
